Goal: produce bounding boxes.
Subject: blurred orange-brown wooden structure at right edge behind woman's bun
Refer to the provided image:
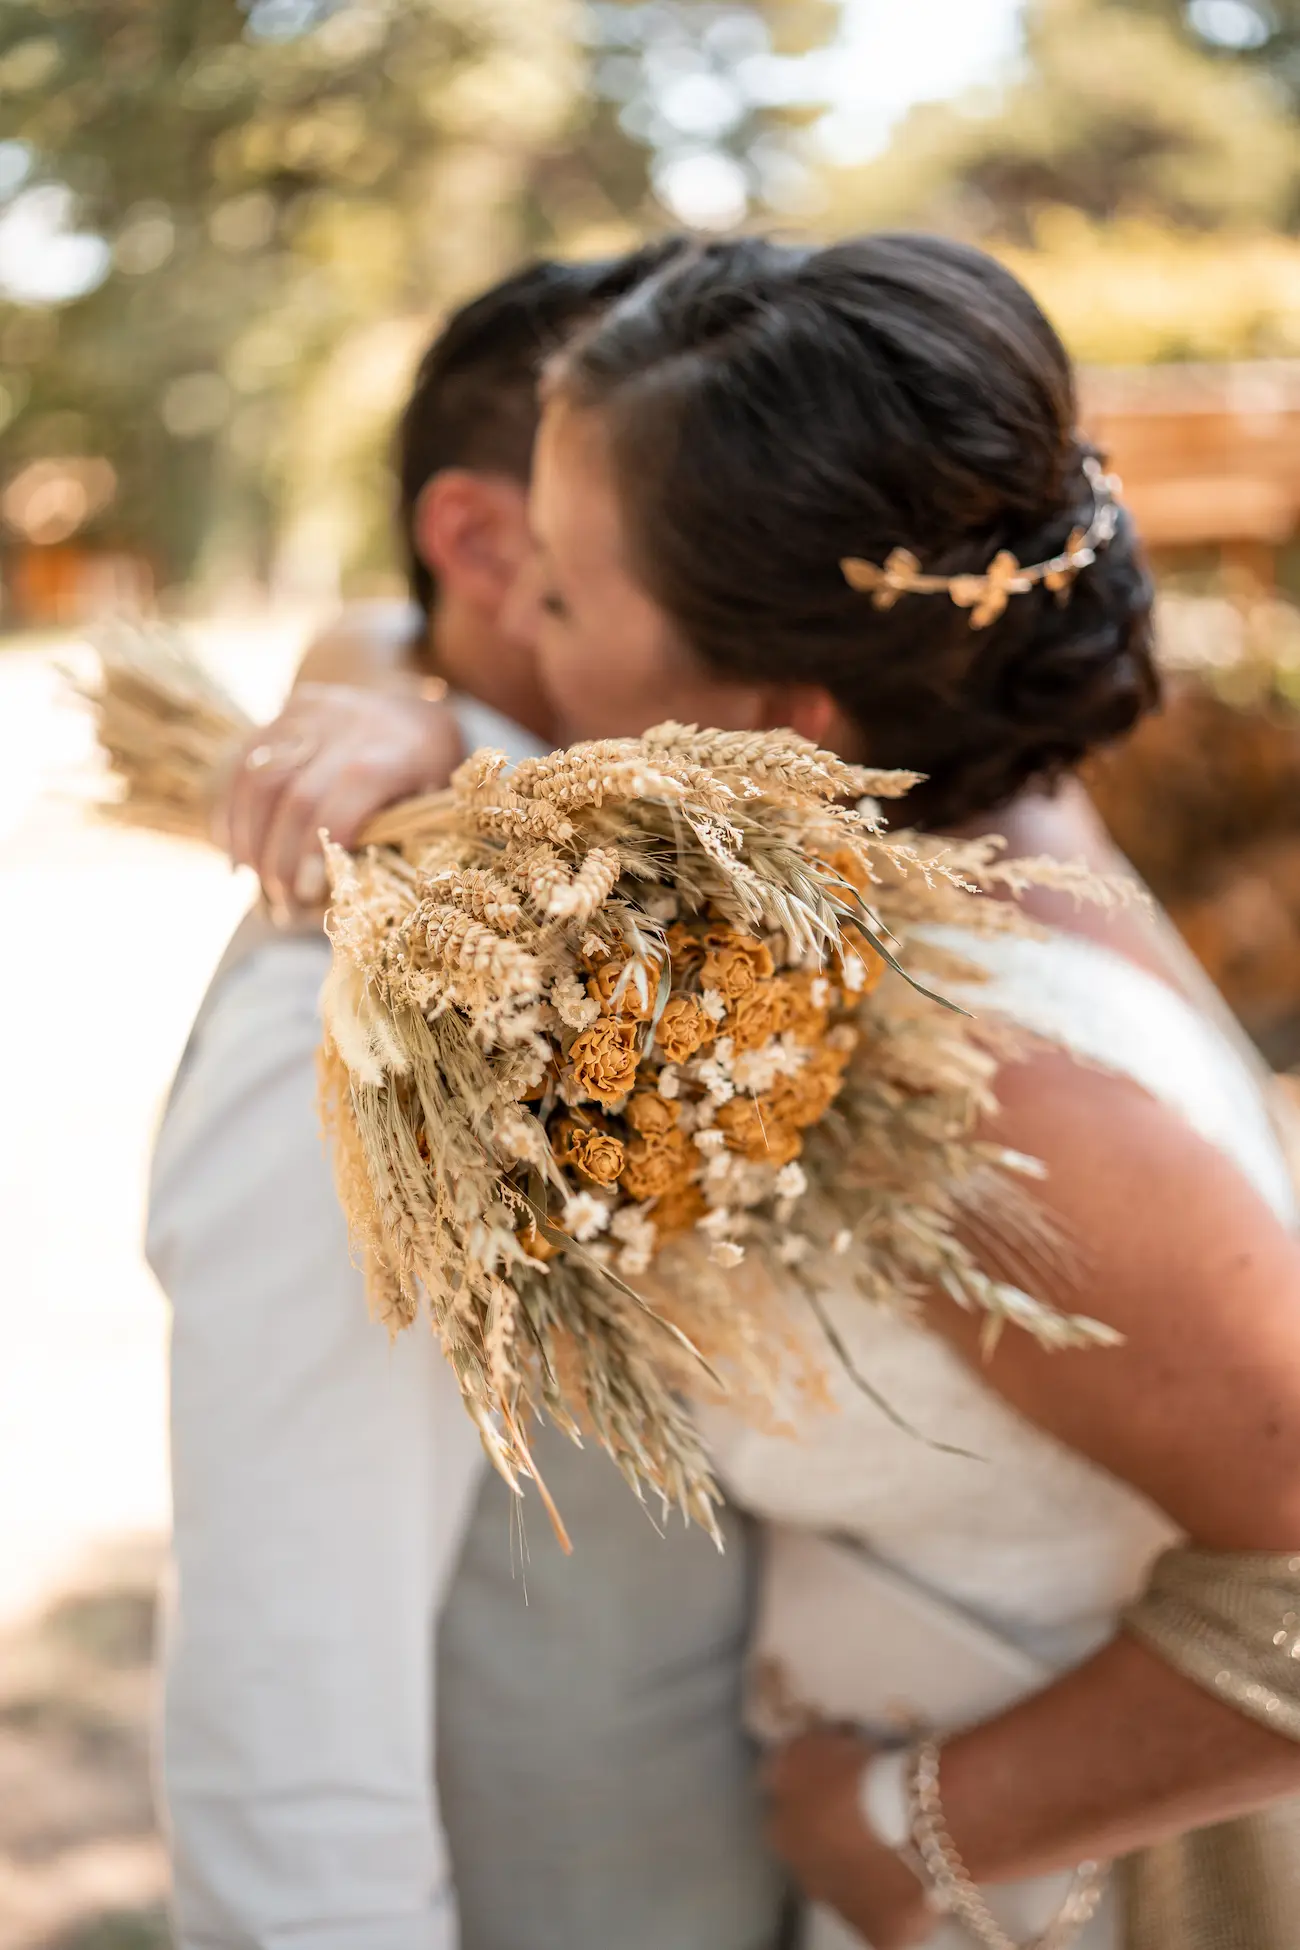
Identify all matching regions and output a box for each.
[1082,359,1300,595]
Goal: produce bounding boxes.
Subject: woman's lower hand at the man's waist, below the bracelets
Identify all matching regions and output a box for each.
[764,1728,939,1950]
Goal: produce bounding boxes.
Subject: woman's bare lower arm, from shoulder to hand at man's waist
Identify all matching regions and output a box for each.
[776,1053,1300,1944]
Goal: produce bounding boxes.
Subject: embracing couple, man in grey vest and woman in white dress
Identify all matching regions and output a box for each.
[150,236,1300,1950]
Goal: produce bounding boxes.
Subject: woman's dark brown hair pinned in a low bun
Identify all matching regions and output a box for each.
[550,234,1158,827]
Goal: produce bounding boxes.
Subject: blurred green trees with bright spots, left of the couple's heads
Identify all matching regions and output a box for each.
[0,0,836,593]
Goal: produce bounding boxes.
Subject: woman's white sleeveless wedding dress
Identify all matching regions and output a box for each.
[706,934,1296,1950]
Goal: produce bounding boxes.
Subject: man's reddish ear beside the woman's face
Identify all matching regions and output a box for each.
[411,468,530,612]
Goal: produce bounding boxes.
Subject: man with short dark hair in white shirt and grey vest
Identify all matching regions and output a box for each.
[150,243,782,1950]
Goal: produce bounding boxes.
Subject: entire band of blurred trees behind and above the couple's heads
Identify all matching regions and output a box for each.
[0,0,1300,601]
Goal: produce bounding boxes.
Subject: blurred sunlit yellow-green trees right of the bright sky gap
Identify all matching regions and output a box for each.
[824,0,1300,363]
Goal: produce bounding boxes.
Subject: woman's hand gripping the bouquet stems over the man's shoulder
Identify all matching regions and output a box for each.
[216,684,464,920]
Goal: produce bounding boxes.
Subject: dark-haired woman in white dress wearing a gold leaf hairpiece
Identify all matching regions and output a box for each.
[230,236,1300,1950]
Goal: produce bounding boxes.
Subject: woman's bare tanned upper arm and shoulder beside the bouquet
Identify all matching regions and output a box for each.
[937,1049,1300,1550]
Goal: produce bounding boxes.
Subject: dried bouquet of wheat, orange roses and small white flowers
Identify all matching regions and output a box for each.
[83,624,1109,1525]
